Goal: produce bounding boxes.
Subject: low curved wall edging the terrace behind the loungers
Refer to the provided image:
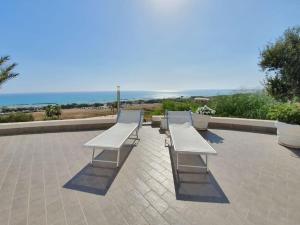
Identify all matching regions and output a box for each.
[0,115,277,136]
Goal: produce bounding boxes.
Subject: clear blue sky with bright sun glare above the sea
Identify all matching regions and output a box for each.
[0,0,300,93]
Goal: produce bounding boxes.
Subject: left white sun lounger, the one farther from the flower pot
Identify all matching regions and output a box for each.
[84,110,142,167]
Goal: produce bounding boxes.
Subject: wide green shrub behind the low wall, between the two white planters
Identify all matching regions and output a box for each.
[208,93,275,119]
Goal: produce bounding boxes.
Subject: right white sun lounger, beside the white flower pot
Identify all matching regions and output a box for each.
[166,111,217,172]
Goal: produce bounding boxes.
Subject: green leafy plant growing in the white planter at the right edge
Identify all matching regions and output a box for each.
[268,103,300,125]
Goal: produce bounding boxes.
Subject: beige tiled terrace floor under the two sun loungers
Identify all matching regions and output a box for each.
[0,127,300,225]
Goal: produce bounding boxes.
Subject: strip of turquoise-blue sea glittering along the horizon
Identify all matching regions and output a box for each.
[0,89,253,107]
